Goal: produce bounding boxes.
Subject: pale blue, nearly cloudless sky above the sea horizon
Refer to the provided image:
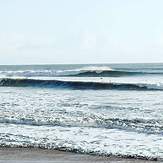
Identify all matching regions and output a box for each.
[0,0,163,65]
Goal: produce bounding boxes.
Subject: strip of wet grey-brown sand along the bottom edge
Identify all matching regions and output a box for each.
[0,148,159,163]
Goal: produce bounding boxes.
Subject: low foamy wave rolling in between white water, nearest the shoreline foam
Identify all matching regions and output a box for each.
[0,116,163,135]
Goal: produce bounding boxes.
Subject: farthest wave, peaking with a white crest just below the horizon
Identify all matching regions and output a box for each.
[0,66,163,77]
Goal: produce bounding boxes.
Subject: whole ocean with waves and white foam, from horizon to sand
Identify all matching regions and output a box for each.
[0,63,163,160]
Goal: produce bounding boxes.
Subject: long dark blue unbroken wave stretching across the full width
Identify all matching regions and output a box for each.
[0,78,163,90]
